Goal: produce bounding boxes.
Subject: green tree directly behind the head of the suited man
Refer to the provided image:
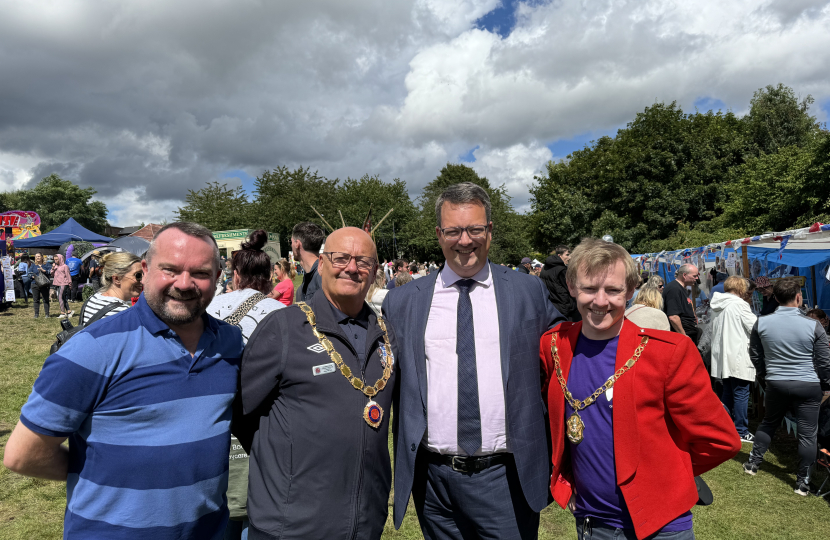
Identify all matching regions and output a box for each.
[401,163,531,264]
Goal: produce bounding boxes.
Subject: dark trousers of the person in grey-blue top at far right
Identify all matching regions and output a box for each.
[749,381,822,482]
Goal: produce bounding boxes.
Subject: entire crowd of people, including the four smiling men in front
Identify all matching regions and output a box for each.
[4,183,830,540]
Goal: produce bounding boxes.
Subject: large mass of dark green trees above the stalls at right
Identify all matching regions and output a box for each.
[530,84,830,253]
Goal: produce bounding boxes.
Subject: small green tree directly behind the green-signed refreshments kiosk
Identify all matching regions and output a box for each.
[175,182,251,231]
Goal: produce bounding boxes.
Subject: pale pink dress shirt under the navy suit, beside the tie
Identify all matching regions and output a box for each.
[424,261,509,455]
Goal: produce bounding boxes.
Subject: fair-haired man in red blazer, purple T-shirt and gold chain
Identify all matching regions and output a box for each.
[540,239,741,540]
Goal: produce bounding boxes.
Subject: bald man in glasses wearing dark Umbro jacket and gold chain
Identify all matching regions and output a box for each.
[232,229,397,540]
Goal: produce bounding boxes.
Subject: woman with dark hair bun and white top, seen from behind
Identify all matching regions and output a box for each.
[207,229,285,540]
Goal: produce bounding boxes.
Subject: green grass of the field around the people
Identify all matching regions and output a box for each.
[0,302,830,540]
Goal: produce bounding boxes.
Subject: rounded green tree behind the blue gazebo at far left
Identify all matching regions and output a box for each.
[15,174,107,234]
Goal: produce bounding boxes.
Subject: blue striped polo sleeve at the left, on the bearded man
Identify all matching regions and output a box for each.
[20,332,113,437]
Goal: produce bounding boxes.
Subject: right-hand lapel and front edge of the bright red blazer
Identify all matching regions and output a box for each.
[613,321,641,484]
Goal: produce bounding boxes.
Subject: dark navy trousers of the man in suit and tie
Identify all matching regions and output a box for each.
[412,449,539,540]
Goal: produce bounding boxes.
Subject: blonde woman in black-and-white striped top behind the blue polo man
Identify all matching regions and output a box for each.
[78,251,144,324]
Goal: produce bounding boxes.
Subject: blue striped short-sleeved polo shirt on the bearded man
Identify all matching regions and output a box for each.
[20,294,242,540]
